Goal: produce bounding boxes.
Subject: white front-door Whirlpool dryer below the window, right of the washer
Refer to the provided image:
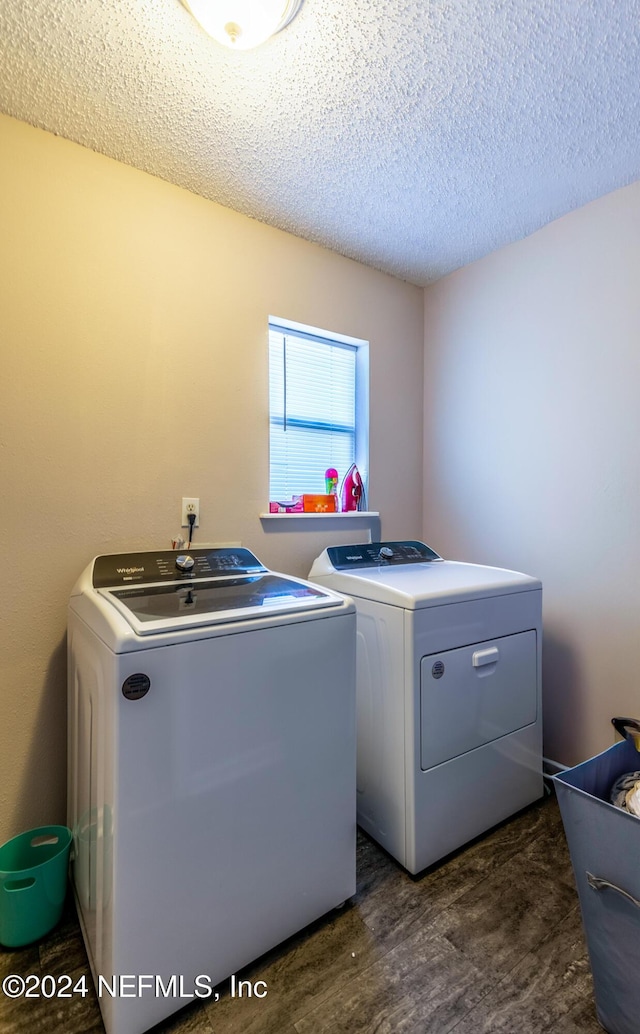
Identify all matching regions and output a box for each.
[309,542,543,873]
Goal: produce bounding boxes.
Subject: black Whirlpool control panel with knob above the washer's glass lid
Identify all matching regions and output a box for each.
[93,547,267,588]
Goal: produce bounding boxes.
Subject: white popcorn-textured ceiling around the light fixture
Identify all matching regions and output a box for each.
[0,0,640,284]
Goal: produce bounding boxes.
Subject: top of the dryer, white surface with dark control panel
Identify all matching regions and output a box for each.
[309,541,541,610]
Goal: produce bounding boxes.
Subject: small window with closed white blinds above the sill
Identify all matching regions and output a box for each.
[269,318,368,500]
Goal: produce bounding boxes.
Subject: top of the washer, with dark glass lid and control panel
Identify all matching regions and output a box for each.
[86,549,341,636]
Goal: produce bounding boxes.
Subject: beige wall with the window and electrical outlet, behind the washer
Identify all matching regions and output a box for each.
[0,117,423,842]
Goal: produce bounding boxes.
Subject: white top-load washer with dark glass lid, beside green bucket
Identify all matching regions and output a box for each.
[68,548,356,1034]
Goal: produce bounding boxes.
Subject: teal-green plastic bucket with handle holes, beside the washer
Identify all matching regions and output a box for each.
[0,826,71,948]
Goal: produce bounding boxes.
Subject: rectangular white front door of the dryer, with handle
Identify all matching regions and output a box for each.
[420,630,537,770]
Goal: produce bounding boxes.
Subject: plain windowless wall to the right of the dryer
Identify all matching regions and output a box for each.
[424,183,640,764]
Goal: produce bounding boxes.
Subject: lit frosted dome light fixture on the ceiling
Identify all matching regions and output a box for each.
[182,0,302,51]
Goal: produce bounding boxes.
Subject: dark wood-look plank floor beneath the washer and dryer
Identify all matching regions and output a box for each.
[0,798,602,1034]
